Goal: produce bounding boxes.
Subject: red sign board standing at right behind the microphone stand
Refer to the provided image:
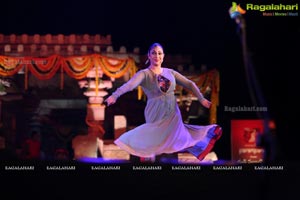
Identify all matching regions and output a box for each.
[231,119,264,163]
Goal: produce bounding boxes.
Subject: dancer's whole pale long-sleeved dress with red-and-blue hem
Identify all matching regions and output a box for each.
[112,68,219,158]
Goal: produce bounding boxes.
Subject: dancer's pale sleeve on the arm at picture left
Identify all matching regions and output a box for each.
[112,71,145,99]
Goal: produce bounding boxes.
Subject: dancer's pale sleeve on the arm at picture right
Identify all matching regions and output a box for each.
[173,70,204,101]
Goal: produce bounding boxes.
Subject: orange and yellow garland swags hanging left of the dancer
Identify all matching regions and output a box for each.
[0,54,137,89]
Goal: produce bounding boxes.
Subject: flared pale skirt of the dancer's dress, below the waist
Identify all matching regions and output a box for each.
[114,101,222,160]
